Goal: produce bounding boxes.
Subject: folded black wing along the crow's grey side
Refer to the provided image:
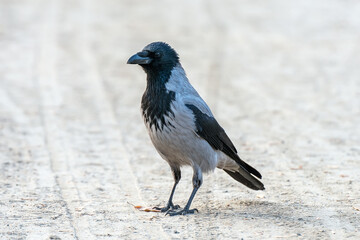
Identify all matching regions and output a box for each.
[185,104,261,179]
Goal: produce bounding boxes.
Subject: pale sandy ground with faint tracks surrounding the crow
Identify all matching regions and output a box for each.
[0,0,360,240]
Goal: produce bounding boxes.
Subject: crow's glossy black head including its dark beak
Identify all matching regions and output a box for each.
[127,42,179,73]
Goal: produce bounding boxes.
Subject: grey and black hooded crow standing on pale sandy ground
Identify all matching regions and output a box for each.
[127,42,265,216]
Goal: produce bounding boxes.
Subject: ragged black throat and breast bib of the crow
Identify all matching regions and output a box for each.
[141,71,175,130]
